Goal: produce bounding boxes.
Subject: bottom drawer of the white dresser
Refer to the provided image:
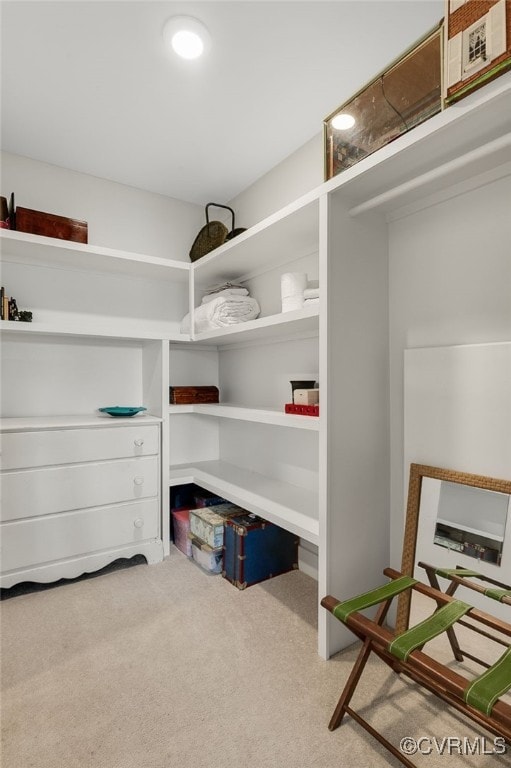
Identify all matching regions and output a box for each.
[0,499,160,573]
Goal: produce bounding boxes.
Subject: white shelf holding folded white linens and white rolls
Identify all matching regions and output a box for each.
[194,304,319,346]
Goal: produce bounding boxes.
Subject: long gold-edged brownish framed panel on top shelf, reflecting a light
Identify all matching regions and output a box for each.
[324,21,444,180]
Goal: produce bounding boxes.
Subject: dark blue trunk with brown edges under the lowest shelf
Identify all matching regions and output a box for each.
[222,513,298,589]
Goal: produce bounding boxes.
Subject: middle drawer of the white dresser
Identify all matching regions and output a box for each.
[1,456,160,520]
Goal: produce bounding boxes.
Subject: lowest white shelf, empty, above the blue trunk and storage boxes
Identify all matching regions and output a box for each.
[169,461,319,544]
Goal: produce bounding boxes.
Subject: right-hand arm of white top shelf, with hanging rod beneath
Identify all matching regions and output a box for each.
[192,72,511,286]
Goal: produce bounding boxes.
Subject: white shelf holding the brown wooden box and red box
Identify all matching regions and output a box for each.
[169,403,319,432]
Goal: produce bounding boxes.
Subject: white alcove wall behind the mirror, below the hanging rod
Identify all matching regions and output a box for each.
[389,177,511,567]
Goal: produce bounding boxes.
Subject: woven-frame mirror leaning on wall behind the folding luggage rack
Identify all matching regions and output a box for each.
[396,464,511,632]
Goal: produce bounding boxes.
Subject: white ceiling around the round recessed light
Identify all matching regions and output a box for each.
[1,0,444,205]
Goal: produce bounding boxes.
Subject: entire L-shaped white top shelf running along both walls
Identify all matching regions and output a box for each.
[0,72,511,286]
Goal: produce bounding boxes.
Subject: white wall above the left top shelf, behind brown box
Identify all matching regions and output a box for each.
[0,152,204,261]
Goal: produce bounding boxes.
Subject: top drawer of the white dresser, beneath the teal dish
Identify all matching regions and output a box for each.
[2,424,160,470]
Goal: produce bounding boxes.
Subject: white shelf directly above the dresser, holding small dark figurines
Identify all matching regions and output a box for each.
[0,320,190,342]
